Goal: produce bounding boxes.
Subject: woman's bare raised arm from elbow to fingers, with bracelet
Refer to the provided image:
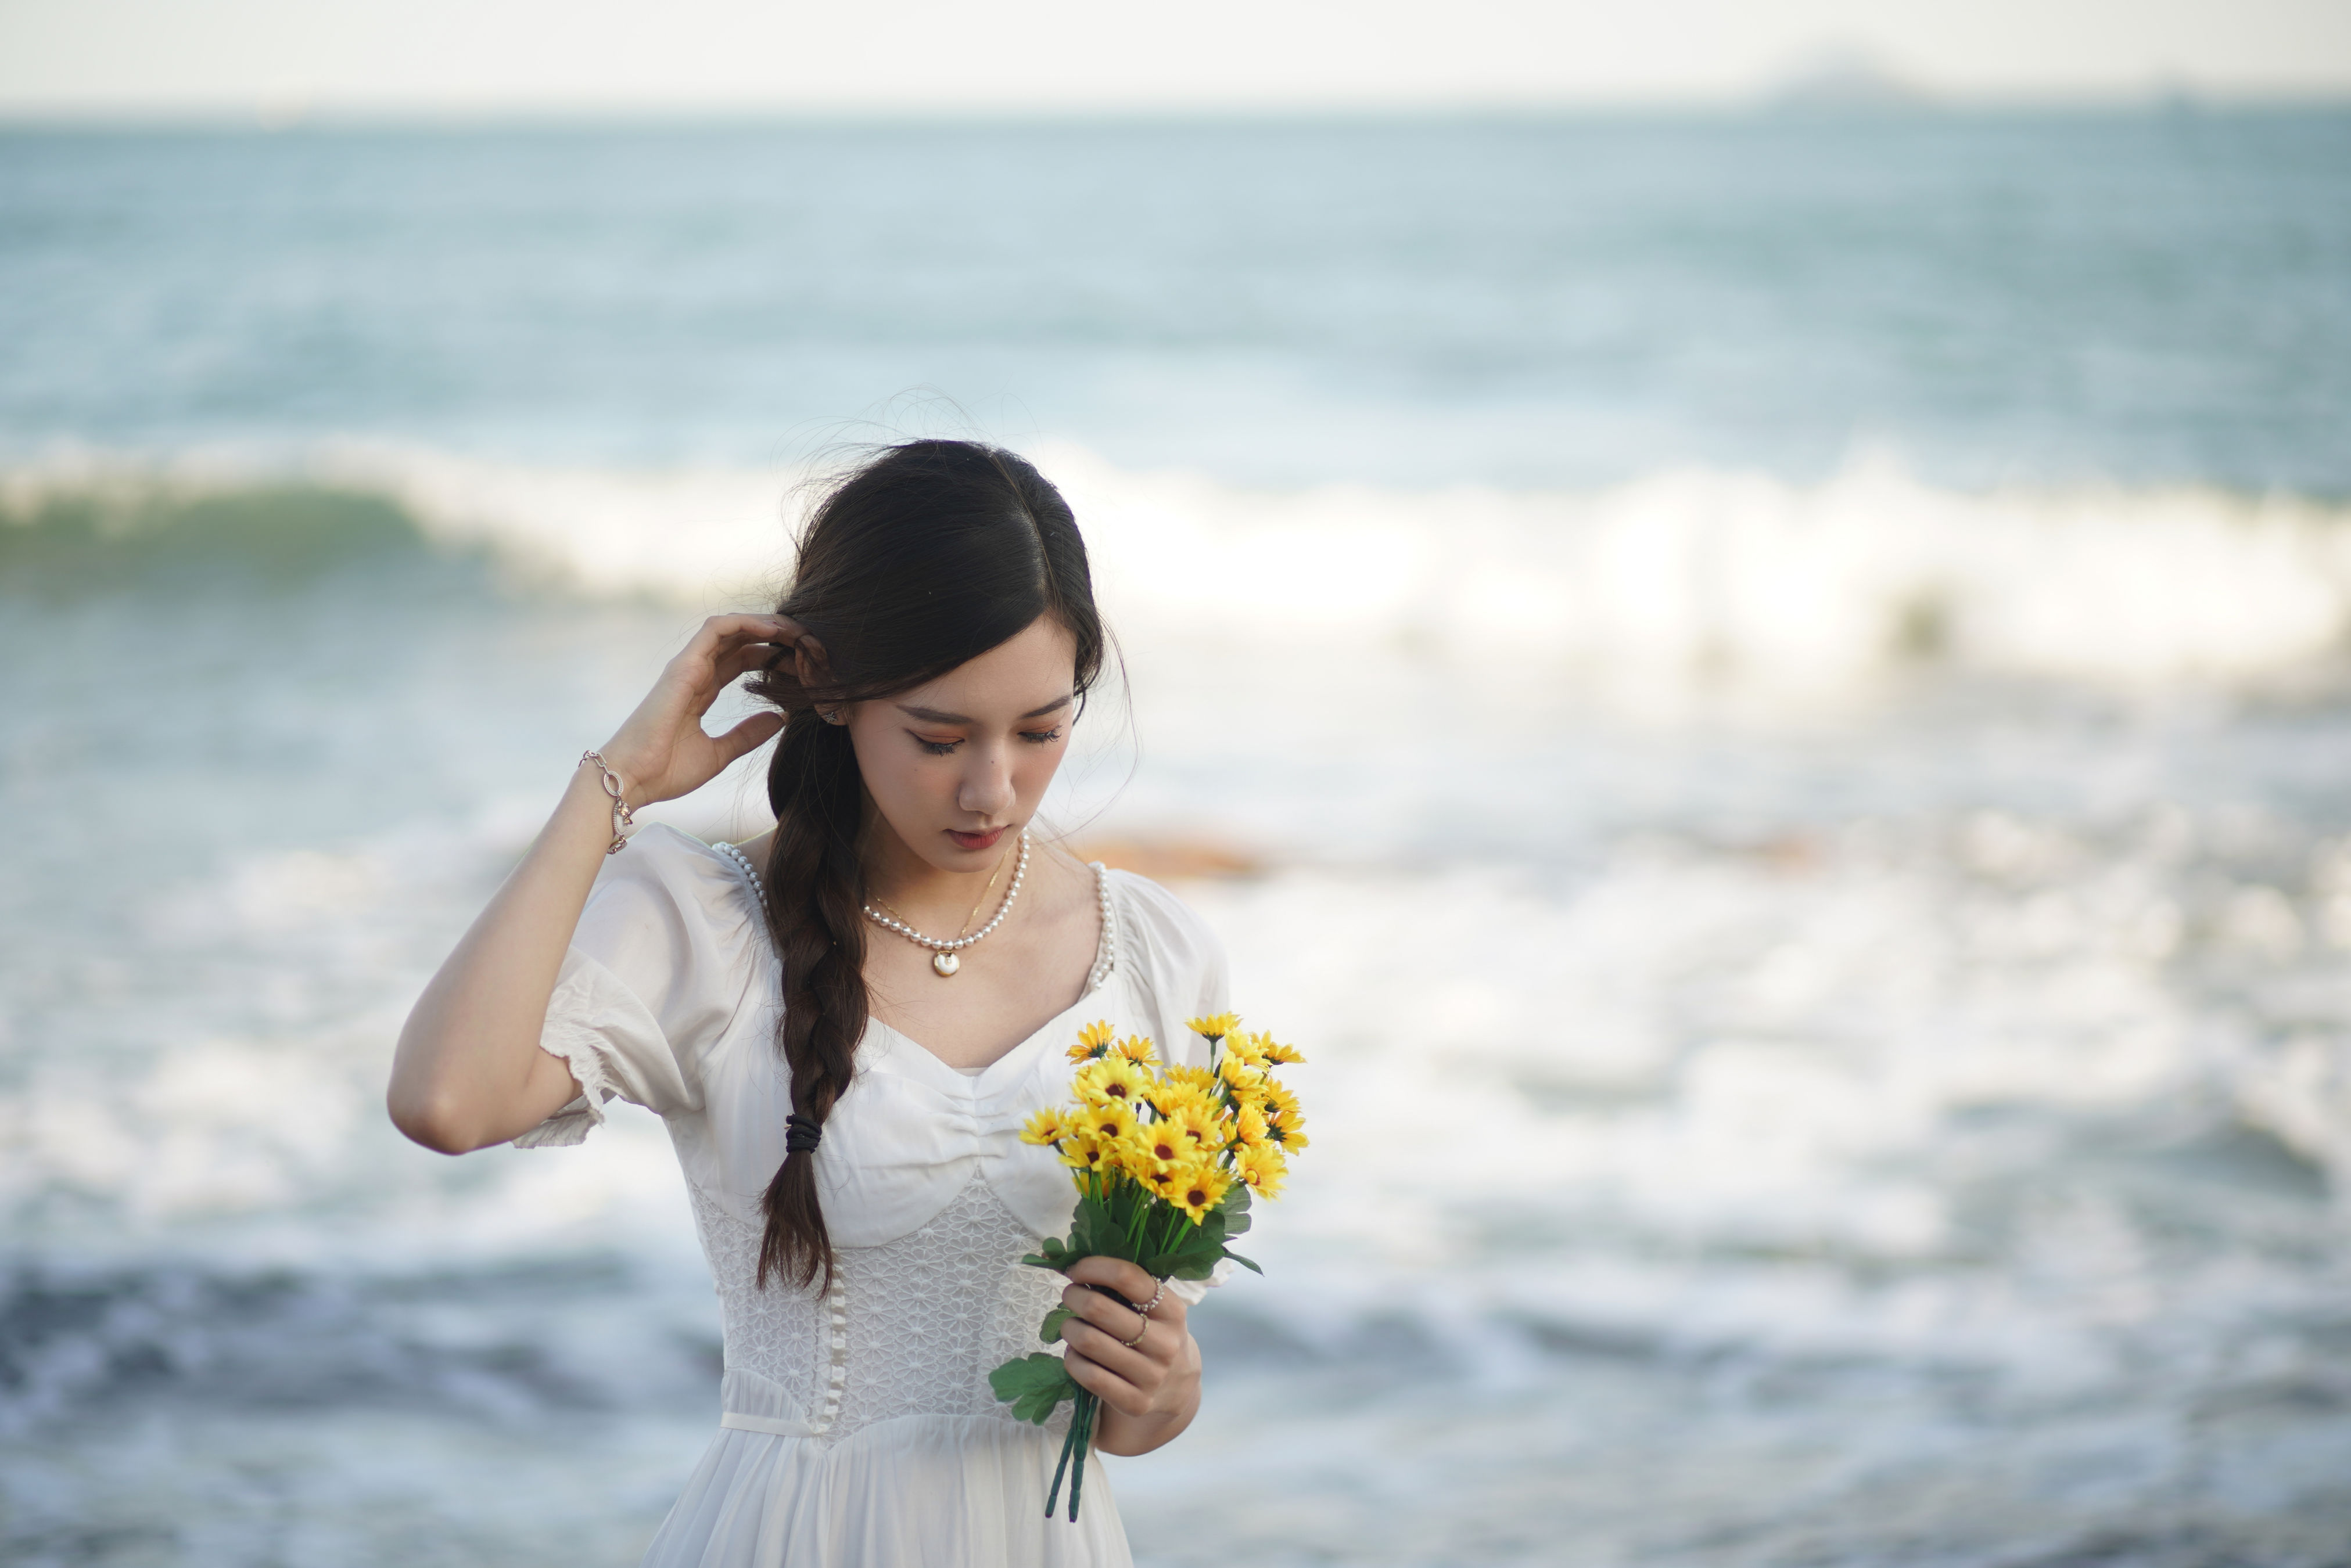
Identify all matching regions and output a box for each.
[386,616,823,1155]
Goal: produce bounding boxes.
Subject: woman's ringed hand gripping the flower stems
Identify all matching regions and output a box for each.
[1060,1258,1199,1453]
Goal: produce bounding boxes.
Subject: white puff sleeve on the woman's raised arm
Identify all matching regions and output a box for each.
[515,828,766,1149]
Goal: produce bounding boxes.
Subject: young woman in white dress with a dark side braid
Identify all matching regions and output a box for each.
[390,442,1225,1568]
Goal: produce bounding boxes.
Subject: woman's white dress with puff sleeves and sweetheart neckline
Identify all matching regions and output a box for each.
[515,828,1225,1568]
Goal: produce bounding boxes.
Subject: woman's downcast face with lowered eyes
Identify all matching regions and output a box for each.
[849,616,1077,872]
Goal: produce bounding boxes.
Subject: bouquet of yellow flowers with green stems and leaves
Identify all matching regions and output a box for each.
[988,1013,1307,1521]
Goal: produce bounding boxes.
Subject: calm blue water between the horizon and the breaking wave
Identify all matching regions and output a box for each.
[0,110,2351,494]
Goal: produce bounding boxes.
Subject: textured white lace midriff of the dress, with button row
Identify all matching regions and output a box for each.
[694,1178,1065,1438]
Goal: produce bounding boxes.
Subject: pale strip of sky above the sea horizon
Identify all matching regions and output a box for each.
[0,0,2351,117]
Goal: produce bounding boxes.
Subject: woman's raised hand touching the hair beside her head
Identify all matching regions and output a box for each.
[602,616,823,809]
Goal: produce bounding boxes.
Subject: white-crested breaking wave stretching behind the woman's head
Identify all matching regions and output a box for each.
[13,447,2351,689]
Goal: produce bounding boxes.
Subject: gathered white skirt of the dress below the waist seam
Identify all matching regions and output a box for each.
[644,1415,1133,1568]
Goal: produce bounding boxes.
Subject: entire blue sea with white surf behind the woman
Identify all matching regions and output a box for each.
[0,110,2351,1568]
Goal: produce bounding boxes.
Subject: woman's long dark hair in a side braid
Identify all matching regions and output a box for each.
[750,440,1105,1288]
